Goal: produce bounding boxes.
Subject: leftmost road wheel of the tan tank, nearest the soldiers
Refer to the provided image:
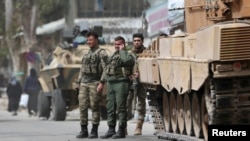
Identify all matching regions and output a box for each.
[163,91,172,132]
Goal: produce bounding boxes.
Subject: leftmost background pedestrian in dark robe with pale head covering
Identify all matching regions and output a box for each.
[6,76,23,116]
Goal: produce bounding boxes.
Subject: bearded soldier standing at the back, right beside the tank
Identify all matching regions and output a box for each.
[127,33,146,135]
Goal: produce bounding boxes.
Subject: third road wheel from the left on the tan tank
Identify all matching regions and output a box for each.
[177,94,185,134]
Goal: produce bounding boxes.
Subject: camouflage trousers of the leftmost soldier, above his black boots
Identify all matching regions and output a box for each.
[78,82,101,125]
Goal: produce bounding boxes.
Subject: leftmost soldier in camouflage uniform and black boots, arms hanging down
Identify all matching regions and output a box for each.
[76,31,108,138]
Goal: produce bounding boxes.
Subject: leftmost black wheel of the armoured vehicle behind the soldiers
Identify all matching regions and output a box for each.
[38,91,51,119]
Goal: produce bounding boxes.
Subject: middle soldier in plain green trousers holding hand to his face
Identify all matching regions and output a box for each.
[101,36,134,139]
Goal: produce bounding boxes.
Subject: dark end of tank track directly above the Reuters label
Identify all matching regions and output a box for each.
[208,77,250,124]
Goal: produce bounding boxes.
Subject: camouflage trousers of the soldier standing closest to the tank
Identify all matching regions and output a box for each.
[127,84,147,120]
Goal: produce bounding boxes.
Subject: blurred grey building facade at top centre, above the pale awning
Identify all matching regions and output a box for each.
[77,0,149,18]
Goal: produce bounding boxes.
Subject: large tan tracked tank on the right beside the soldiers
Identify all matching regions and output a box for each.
[138,0,250,140]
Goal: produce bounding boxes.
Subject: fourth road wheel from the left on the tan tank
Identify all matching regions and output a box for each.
[184,94,192,136]
